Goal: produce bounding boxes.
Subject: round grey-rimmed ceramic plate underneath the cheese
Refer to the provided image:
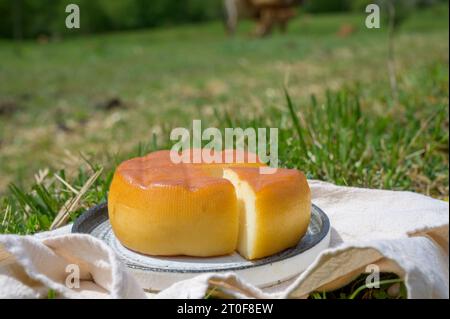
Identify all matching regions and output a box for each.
[72,204,330,291]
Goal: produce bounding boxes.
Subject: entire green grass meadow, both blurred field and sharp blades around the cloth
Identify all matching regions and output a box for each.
[0,7,449,298]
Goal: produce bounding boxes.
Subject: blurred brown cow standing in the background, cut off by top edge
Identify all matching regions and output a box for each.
[224,0,303,37]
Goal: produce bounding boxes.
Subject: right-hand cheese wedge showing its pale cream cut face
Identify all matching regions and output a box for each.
[224,168,311,259]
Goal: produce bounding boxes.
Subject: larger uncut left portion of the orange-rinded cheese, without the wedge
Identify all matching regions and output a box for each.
[108,152,238,257]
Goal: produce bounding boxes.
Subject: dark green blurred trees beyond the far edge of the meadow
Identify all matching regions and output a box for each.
[0,0,446,38]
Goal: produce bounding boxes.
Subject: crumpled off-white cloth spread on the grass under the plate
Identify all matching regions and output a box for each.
[0,181,449,298]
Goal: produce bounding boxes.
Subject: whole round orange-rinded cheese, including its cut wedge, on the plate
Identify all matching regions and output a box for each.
[108,150,311,259]
